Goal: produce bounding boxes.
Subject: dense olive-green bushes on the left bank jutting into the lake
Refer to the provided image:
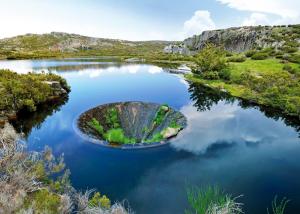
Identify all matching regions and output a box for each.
[0,70,70,117]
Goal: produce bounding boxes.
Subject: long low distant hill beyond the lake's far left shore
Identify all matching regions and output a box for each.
[0,32,172,58]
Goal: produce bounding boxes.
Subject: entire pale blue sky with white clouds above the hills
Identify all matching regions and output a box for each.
[0,0,300,41]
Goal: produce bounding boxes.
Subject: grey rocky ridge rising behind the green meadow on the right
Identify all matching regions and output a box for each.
[164,25,300,55]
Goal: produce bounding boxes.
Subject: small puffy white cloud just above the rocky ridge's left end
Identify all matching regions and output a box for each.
[183,10,216,36]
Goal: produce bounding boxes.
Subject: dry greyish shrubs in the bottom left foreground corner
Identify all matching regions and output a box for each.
[0,123,130,214]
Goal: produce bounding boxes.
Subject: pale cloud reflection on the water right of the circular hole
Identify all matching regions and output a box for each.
[171,101,296,154]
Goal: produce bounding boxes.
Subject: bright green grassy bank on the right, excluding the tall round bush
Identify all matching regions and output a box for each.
[185,59,300,118]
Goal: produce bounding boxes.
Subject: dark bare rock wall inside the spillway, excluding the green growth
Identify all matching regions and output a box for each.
[78,102,187,142]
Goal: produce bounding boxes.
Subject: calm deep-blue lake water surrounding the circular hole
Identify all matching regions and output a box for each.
[0,59,300,214]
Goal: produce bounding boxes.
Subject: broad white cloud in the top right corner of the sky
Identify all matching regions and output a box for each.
[217,0,300,25]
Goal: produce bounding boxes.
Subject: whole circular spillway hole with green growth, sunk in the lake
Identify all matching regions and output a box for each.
[78,102,187,148]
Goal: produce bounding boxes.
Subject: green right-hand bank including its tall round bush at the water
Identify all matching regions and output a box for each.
[186,45,300,117]
